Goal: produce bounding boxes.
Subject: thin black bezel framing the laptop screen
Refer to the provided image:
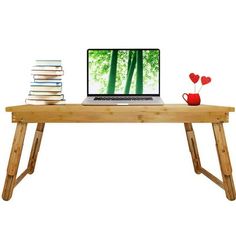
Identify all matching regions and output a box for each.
[87,48,161,97]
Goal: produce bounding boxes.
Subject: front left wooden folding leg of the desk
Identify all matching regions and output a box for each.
[2,122,27,200]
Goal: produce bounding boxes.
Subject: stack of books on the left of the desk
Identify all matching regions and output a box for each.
[25,60,65,105]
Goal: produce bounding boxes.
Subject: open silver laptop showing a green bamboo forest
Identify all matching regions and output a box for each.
[82,49,163,105]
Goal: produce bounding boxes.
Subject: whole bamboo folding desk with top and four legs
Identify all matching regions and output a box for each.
[2,104,236,200]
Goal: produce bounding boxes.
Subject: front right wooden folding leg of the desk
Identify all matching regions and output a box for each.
[212,123,236,200]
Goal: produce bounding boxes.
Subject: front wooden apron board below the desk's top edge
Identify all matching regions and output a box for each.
[12,111,228,123]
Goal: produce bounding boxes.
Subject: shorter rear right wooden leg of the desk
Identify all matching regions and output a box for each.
[184,123,201,174]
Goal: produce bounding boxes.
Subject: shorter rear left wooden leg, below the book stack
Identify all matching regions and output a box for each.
[27,123,45,174]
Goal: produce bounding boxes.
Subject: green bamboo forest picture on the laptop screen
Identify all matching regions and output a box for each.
[88,49,160,95]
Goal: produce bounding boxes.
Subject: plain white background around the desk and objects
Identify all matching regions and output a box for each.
[0,0,236,236]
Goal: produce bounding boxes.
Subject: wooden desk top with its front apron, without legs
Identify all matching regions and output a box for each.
[6,104,235,123]
